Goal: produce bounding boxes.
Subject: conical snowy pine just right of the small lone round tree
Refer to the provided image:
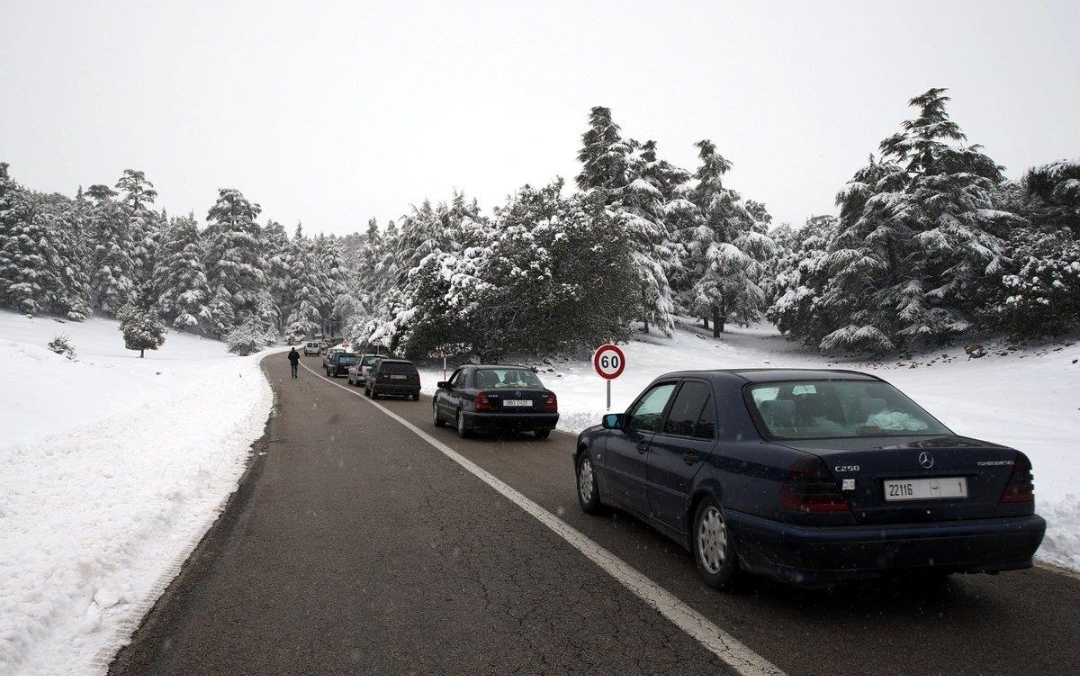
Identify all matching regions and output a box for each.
[154,214,213,332]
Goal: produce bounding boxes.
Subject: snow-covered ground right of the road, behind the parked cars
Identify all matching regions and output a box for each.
[420,321,1080,570]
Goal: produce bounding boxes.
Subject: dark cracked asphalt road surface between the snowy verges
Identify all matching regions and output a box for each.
[110,355,1080,676]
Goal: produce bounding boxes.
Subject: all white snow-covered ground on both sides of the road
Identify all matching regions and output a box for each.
[0,311,1080,676]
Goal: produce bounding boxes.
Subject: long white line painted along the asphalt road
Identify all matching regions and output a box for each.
[303,364,785,676]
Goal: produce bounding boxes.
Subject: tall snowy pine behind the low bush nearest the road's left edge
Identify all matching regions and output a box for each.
[204,188,267,333]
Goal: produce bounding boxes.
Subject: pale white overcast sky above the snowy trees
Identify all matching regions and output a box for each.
[0,0,1080,234]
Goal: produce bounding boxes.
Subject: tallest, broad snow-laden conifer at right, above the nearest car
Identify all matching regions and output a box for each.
[821,89,1022,351]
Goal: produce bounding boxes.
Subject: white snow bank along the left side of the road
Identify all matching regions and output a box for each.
[0,312,273,676]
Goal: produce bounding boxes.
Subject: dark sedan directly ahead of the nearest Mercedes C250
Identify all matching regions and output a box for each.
[432,364,558,438]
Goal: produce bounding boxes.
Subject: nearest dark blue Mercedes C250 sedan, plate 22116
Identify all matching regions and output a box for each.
[573,369,1047,589]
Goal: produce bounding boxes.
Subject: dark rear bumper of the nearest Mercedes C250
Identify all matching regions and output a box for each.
[726,511,1047,584]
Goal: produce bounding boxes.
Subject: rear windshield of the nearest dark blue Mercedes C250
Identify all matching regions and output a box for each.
[746,380,951,440]
